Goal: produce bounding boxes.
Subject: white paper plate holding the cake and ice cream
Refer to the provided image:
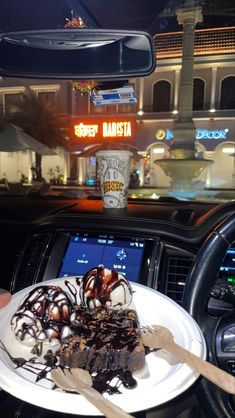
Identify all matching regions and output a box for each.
[0,278,206,415]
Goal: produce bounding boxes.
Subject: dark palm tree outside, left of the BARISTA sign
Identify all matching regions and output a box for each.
[8,94,67,181]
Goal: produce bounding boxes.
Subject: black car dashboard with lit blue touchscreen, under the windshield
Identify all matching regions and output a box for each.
[0,198,235,310]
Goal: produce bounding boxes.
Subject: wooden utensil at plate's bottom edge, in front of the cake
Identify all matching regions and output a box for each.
[51,367,133,418]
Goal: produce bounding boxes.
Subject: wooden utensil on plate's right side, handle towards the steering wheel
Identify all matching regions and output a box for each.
[141,325,235,395]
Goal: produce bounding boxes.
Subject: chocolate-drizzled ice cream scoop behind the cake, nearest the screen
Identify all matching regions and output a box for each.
[80,267,132,309]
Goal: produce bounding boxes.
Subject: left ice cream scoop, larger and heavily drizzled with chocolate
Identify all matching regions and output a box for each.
[11,286,72,346]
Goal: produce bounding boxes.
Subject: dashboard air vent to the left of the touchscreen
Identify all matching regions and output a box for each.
[11,233,50,292]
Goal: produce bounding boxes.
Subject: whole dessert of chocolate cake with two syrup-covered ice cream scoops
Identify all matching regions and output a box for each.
[11,266,145,393]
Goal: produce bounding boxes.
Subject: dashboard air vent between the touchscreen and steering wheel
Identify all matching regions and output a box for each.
[165,255,194,304]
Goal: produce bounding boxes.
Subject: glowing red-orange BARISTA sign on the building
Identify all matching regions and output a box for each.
[73,121,134,139]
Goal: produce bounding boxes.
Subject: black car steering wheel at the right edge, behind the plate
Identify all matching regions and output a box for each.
[183,214,235,418]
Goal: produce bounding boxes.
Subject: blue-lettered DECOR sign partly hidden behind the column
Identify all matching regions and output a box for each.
[156,128,229,141]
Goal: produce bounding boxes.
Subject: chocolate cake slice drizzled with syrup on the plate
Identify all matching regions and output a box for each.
[57,306,145,373]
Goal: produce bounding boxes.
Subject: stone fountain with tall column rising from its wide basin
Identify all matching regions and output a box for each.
[155,0,213,192]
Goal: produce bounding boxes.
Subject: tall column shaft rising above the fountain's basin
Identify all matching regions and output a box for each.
[171,0,202,159]
